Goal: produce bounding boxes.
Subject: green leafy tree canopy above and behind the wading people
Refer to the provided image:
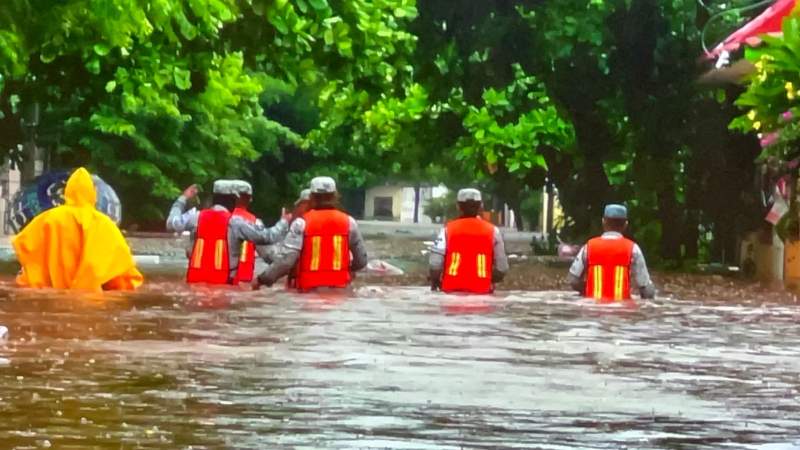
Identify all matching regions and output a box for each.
[0,0,789,260]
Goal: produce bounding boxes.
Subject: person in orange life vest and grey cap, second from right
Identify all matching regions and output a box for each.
[429,189,508,294]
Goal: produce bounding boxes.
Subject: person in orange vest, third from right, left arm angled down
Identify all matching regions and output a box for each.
[253,177,367,292]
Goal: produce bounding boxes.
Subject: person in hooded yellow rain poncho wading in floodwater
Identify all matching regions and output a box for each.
[12,168,144,291]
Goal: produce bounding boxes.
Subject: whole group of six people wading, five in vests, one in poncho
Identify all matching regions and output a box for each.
[12,168,655,302]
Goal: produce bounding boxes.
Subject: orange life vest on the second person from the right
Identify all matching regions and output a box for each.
[442,217,494,294]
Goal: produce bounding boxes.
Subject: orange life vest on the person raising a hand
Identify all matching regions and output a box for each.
[186,209,231,284]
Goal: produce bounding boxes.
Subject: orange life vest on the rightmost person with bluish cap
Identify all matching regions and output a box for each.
[586,237,634,303]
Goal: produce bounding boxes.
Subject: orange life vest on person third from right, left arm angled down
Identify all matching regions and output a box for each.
[296,209,350,291]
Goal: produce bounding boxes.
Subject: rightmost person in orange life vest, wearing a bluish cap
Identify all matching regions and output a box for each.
[567,204,656,302]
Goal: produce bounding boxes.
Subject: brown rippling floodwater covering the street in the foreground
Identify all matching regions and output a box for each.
[0,282,800,450]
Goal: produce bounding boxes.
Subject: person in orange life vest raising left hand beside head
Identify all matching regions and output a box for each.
[167,180,291,284]
